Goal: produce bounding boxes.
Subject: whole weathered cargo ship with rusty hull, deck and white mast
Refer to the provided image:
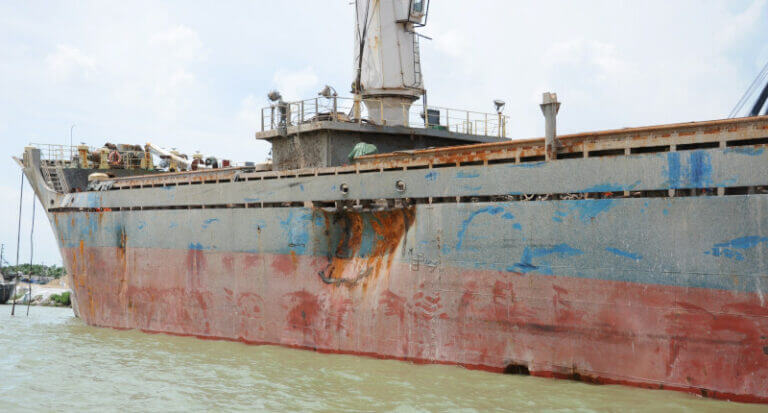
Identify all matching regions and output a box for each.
[16,0,768,403]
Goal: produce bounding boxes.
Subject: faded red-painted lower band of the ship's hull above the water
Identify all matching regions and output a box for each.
[64,246,768,403]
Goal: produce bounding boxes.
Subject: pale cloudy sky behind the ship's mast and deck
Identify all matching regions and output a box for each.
[0,0,768,264]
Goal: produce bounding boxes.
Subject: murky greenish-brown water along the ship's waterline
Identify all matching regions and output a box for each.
[0,305,765,412]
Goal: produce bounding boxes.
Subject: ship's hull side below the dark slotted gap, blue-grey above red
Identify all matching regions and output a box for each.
[52,196,768,402]
